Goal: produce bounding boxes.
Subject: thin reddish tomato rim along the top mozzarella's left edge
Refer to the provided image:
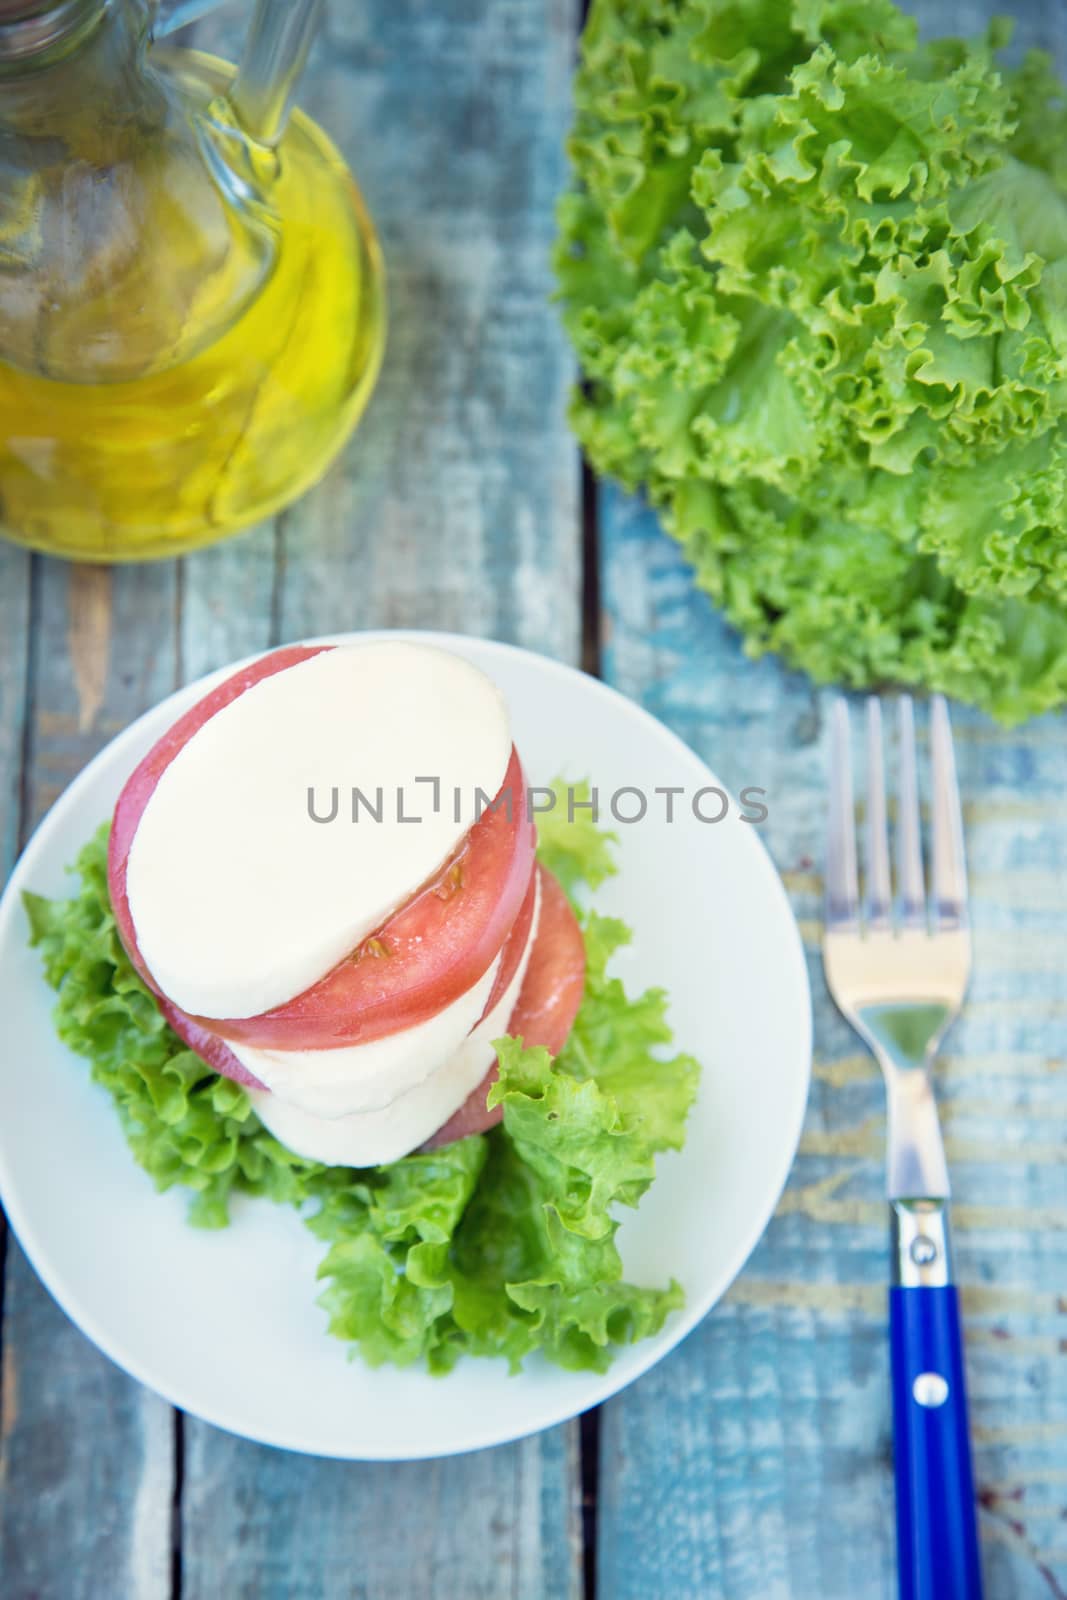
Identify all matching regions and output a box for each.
[107,645,333,992]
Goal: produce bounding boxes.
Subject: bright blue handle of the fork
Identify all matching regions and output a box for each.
[889,1283,982,1600]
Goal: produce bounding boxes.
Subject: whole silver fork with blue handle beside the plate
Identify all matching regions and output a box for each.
[822,696,982,1600]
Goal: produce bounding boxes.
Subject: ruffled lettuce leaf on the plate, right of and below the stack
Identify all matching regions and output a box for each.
[312,908,699,1371]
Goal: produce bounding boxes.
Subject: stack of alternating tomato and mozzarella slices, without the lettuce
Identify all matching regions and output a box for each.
[109,642,584,1166]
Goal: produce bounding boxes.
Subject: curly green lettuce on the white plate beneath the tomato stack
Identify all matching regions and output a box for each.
[26,812,699,1373]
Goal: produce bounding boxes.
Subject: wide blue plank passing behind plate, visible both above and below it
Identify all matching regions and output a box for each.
[181,0,581,1600]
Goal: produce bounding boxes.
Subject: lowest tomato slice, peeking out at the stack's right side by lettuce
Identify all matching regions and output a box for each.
[422,867,585,1150]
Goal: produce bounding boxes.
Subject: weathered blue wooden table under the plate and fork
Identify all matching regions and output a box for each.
[0,0,1067,1600]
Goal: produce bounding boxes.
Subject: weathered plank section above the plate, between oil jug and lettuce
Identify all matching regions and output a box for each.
[254,0,581,659]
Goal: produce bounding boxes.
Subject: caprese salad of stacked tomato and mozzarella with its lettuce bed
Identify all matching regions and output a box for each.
[24,638,699,1373]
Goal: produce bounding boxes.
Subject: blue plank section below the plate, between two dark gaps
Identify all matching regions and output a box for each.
[182,1426,581,1600]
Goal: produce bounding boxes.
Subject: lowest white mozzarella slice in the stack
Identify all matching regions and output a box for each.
[248,882,541,1166]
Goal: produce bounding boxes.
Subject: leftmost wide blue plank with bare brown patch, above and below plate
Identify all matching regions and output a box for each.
[0,552,176,1600]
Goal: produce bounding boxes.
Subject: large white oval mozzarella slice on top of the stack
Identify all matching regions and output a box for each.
[126,642,510,1018]
